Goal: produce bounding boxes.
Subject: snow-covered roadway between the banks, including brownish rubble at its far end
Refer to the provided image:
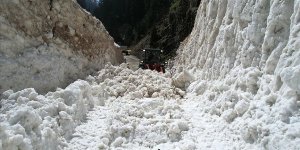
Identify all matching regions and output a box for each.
[65,67,258,150]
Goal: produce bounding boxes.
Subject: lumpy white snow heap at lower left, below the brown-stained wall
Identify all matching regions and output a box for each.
[0,80,104,150]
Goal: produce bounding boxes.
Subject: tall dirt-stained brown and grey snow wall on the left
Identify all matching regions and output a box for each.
[0,0,121,92]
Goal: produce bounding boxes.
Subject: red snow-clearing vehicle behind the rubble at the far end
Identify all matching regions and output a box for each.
[139,48,165,73]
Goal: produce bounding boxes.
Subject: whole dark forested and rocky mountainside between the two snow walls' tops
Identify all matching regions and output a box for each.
[77,0,200,58]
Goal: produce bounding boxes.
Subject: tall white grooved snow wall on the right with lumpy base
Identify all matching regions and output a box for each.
[175,0,300,149]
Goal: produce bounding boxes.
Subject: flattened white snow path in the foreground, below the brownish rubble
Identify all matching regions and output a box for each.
[66,94,254,150]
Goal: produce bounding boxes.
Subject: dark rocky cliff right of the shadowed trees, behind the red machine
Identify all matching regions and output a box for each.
[146,0,201,59]
